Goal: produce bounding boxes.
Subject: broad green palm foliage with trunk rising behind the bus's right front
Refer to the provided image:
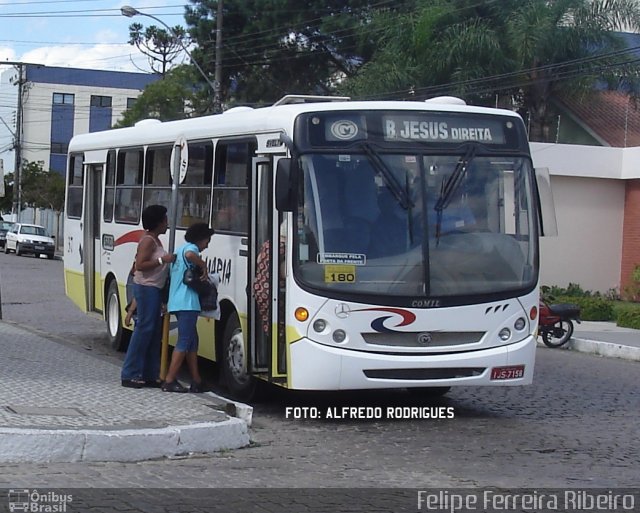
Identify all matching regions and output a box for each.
[341,0,640,141]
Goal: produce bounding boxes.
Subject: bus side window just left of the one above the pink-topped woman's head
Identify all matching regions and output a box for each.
[114,149,143,224]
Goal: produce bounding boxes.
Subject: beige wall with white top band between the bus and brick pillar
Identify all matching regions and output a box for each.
[531,143,624,292]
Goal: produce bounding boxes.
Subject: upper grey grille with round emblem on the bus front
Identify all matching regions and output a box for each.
[362,331,485,347]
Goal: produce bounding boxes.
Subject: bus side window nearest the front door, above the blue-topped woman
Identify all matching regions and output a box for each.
[211,140,257,234]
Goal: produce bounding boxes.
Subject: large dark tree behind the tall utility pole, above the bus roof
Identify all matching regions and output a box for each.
[185,0,414,104]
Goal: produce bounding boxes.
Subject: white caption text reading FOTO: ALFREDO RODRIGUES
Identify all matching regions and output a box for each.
[284,406,455,420]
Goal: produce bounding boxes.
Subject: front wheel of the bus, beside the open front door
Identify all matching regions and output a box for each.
[222,313,256,401]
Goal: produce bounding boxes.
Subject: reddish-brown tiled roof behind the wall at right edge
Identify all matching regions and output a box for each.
[561,91,640,148]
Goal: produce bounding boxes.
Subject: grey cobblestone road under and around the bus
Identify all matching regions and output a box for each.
[0,254,640,488]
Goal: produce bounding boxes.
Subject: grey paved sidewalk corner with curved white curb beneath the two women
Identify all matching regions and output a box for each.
[0,321,251,463]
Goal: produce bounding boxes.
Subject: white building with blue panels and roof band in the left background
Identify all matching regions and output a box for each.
[0,64,158,173]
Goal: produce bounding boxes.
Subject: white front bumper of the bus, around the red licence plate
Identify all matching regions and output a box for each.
[290,336,536,390]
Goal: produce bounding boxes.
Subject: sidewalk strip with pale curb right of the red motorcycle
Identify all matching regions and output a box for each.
[538,321,640,362]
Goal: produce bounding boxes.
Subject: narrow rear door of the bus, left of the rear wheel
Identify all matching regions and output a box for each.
[82,164,104,312]
